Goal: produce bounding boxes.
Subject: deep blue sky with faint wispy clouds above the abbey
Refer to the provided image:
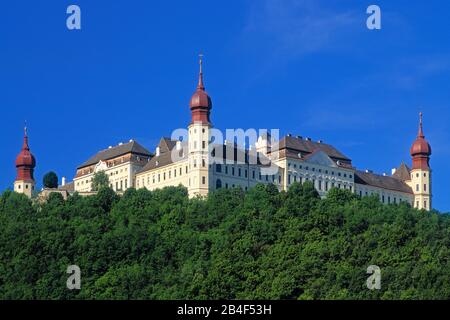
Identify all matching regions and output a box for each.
[0,0,450,211]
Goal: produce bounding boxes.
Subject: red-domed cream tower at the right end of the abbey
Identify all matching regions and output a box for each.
[411,113,432,211]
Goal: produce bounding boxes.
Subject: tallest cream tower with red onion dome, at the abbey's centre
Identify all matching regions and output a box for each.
[188,55,212,197]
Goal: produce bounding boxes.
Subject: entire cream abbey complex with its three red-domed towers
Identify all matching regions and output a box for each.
[14,60,432,210]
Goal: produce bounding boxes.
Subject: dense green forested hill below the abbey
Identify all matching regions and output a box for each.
[0,183,450,299]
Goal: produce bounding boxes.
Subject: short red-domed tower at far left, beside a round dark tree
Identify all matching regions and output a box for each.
[14,127,36,198]
